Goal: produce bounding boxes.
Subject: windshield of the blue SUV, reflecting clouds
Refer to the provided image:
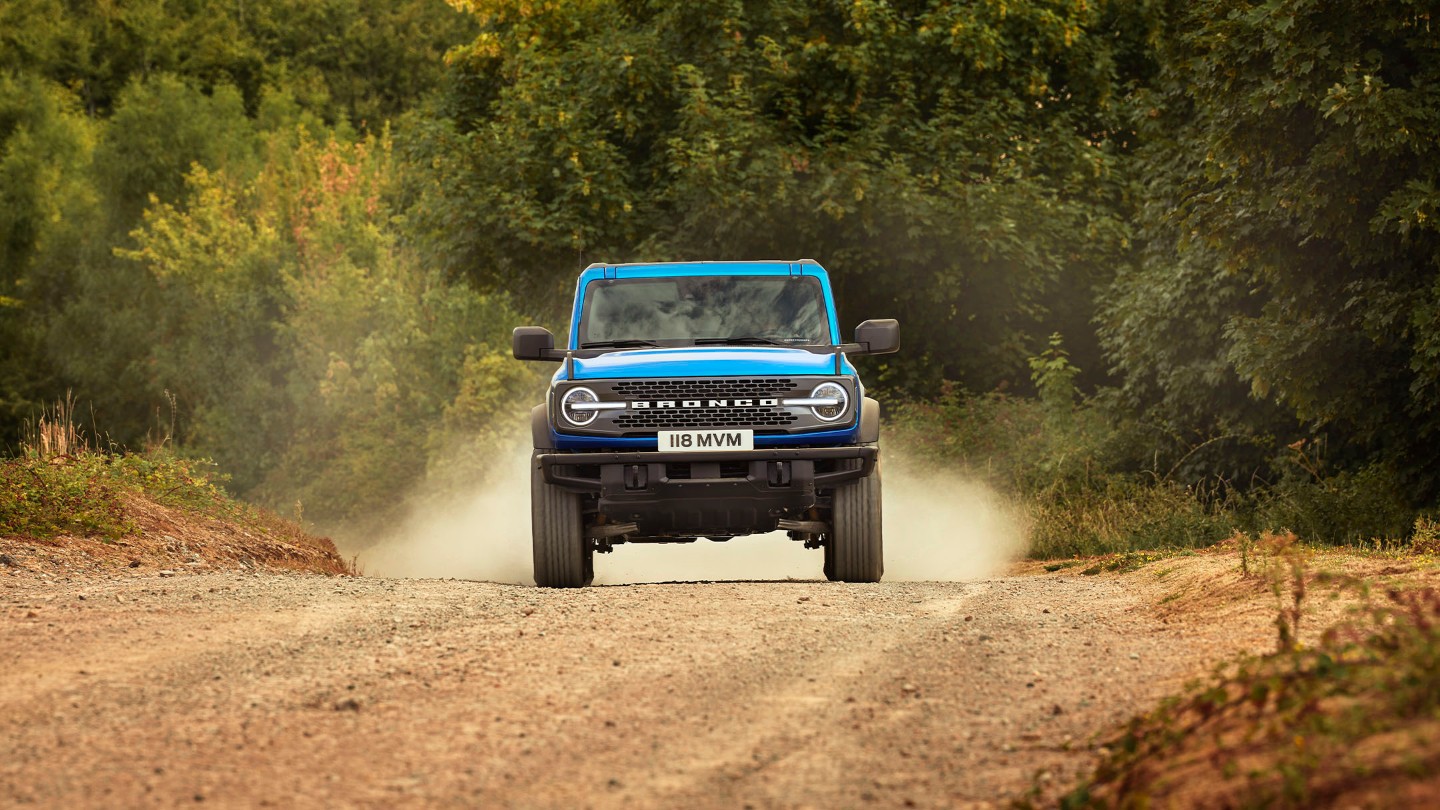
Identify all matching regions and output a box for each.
[579,275,829,349]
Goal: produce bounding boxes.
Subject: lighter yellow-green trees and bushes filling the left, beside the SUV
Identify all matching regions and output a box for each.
[0,0,533,530]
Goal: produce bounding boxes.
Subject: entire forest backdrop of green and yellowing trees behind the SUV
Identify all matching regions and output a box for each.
[0,0,1440,553]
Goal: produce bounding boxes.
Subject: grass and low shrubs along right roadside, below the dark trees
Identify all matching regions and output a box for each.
[886,374,1440,559]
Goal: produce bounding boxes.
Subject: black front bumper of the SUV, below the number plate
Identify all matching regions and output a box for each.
[536,445,878,538]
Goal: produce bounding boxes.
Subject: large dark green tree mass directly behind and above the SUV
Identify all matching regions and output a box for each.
[413,0,1132,392]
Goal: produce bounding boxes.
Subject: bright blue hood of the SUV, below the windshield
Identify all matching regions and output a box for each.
[560,346,855,379]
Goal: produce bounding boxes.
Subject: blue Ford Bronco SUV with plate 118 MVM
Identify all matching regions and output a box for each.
[514,259,900,588]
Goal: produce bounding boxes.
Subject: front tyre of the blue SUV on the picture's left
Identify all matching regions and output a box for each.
[530,446,595,588]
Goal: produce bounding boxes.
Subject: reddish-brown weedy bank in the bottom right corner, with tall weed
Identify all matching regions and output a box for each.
[1060,544,1440,809]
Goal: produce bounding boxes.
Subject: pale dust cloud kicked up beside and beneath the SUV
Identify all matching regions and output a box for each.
[357,450,1025,585]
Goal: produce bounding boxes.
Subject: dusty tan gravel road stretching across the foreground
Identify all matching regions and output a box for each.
[0,572,1263,807]
